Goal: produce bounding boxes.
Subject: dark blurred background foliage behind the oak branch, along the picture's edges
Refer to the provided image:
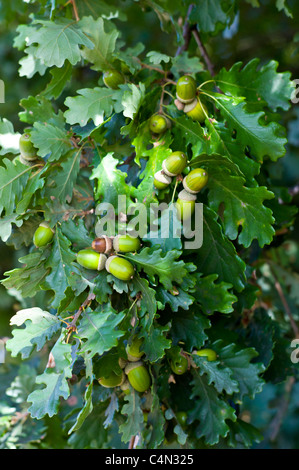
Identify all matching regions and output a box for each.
[0,0,299,449]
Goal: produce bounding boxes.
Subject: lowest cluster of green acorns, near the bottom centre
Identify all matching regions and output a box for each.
[98,336,151,394]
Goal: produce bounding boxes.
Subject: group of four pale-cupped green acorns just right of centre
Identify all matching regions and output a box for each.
[154,151,208,221]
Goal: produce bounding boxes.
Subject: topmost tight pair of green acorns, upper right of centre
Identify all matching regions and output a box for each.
[175,75,208,123]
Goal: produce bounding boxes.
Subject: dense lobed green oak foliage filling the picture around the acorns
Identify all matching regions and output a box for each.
[0,0,299,449]
